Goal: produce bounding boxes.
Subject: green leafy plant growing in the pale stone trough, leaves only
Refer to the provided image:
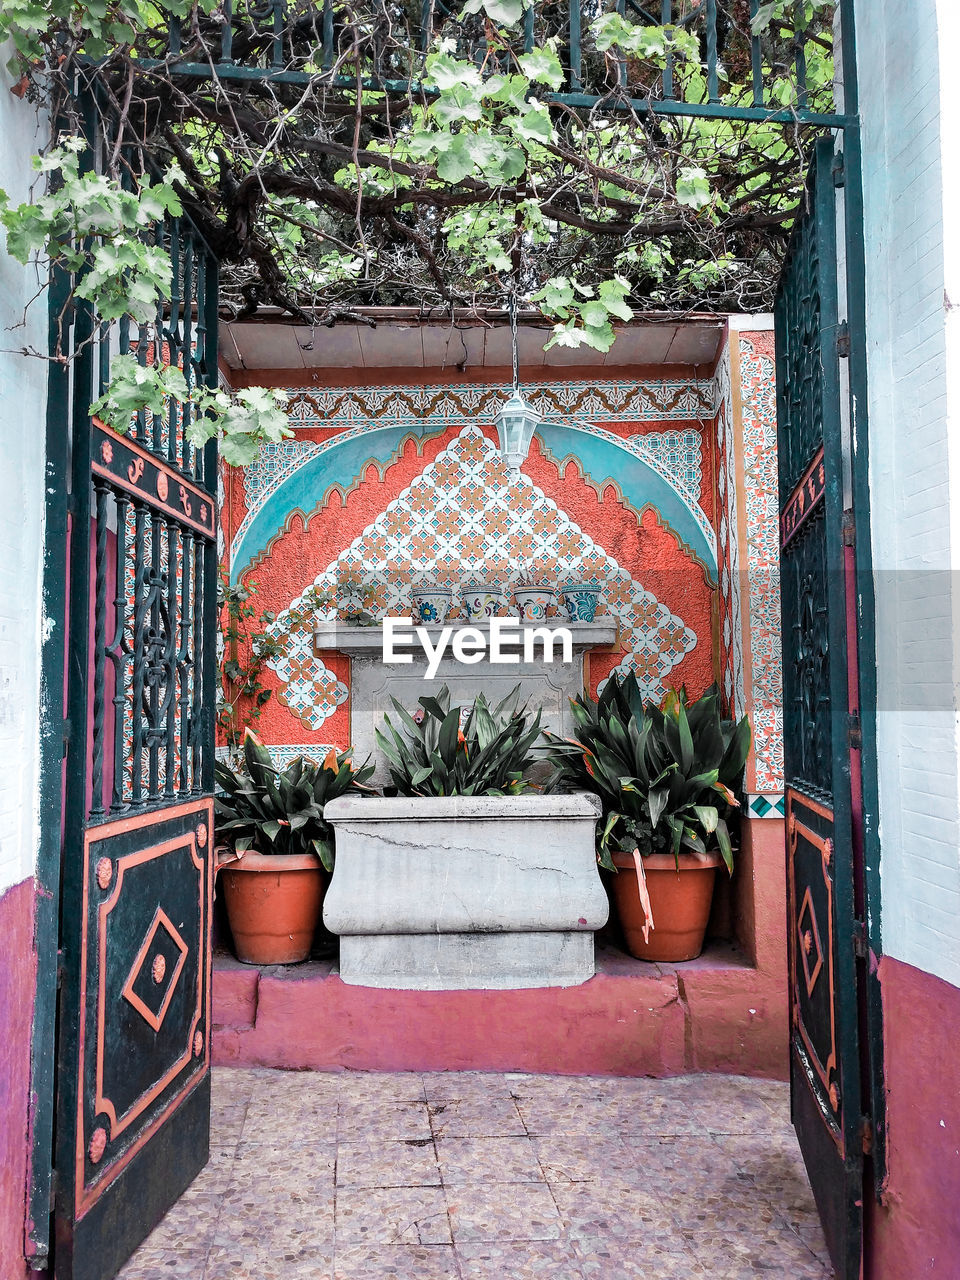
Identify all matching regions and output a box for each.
[376,685,540,796]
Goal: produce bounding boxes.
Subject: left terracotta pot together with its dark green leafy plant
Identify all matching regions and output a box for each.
[214,728,374,964]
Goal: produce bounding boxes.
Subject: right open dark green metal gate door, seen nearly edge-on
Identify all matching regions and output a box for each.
[776,140,864,1280]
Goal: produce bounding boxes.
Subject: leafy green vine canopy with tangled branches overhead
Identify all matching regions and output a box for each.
[0,0,833,440]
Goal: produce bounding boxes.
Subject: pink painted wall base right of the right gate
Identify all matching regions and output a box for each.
[865,956,960,1280]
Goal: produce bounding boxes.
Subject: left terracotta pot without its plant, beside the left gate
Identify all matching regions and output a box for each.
[220,851,326,964]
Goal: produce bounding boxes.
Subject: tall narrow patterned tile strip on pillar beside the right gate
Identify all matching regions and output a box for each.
[739,333,783,792]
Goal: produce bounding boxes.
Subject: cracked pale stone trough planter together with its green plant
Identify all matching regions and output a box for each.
[324,686,608,991]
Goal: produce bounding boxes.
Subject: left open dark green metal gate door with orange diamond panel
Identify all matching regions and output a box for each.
[54,221,216,1280]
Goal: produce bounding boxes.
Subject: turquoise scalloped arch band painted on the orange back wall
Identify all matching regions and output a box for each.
[230,422,717,584]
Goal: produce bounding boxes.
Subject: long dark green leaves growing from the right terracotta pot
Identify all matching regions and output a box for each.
[545,672,750,872]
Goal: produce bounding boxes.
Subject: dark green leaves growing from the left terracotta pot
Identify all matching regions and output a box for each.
[214,728,374,872]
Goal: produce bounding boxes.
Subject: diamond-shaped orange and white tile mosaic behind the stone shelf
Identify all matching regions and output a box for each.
[270,424,698,730]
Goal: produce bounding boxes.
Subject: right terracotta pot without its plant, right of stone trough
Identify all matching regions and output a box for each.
[613,854,722,961]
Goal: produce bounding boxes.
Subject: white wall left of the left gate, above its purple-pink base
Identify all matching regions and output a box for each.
[0,64,47,893]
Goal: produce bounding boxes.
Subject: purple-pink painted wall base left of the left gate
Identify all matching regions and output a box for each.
[0,879,36,1280]
